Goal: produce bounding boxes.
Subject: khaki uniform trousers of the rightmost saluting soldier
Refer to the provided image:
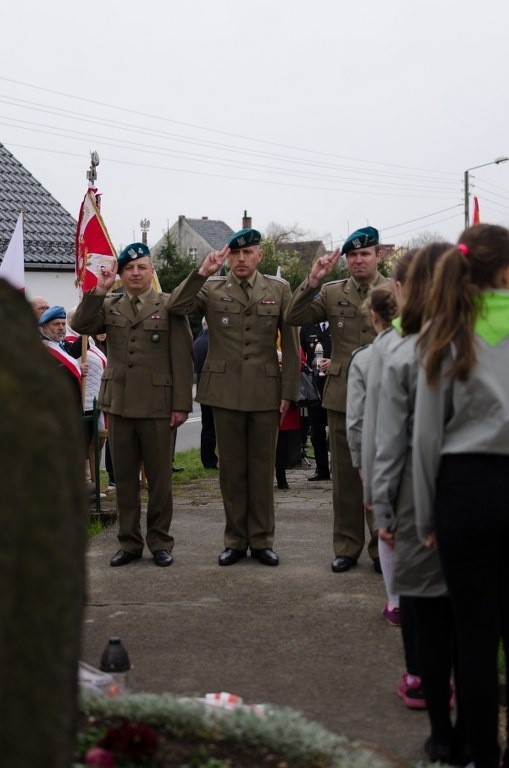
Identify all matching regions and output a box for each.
[327,410,378,560]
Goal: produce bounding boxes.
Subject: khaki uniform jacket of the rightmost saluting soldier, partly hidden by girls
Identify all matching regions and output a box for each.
[286,273,387,413]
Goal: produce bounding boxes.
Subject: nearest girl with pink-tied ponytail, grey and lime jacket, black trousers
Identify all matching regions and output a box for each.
[413,224,509,768]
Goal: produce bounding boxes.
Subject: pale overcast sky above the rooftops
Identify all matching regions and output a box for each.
[0,0,509,252]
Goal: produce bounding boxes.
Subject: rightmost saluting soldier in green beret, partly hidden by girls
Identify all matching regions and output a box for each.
[286,227,386,573]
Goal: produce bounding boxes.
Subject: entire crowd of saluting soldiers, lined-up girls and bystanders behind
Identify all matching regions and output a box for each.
[29,224,509,768]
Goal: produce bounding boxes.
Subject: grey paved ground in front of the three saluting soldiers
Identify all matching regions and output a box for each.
[82,469,428,764]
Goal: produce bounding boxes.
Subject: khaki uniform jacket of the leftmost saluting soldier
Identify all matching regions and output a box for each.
[73,290,193,419]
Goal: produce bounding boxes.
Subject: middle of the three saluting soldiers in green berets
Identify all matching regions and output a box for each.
[168,228,300,565]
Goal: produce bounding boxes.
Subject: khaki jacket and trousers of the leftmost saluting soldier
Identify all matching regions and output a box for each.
[73,290,193,555]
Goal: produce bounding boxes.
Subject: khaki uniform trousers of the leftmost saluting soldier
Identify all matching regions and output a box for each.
[108,414,175,555]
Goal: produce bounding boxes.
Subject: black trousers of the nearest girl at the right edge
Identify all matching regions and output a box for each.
[435,453,509,768]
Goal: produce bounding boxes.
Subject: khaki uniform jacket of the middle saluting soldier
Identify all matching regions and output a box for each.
[168,270,300,411]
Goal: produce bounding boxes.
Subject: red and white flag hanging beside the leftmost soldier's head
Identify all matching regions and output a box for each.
[76,187,117,294]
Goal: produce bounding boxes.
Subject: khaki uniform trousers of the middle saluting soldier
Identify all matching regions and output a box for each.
[214,407,280,550]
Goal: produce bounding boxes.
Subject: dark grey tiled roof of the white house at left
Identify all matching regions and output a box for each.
[0,144,76,269]
